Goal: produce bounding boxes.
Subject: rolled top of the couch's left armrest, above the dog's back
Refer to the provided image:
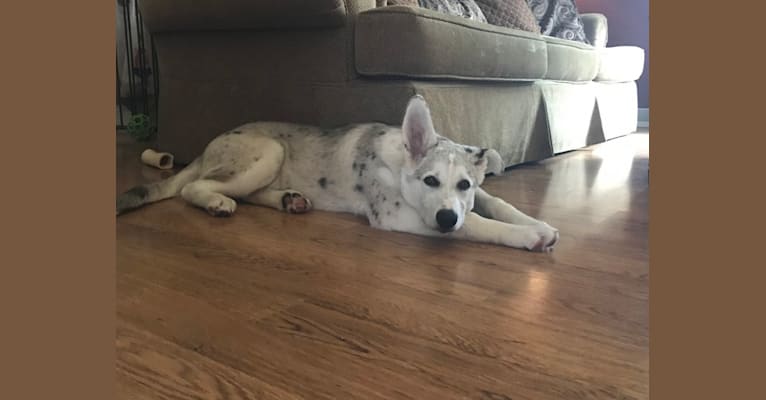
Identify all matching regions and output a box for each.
[139,0,375,33]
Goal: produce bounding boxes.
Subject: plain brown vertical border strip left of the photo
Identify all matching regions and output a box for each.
[0,0,115,400]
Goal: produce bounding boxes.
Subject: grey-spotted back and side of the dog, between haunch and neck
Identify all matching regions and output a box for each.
[233,122,403,214]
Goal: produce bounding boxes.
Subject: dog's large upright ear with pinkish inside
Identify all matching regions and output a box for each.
[402,95,436,162]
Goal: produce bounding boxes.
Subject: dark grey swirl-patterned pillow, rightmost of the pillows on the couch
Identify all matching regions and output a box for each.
[527,0,590,44]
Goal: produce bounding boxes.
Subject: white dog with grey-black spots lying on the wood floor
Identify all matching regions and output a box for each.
[117,95,559,251]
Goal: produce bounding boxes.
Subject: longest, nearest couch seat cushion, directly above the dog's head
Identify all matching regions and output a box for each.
[355,7,548,80]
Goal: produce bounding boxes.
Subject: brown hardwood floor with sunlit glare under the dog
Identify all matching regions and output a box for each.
[116,134,649,400]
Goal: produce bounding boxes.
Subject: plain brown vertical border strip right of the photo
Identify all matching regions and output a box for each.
[649,1,766,400]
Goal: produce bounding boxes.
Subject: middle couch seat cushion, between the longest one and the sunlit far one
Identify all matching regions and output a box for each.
[544,36,599,82]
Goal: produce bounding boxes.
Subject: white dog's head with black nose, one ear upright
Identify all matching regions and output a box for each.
[401,96,503,233]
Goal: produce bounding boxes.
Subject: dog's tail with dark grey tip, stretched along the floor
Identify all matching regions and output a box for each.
[117,158,202,215]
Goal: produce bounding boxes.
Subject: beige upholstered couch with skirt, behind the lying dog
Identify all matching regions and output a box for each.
[139,0,644,166]
